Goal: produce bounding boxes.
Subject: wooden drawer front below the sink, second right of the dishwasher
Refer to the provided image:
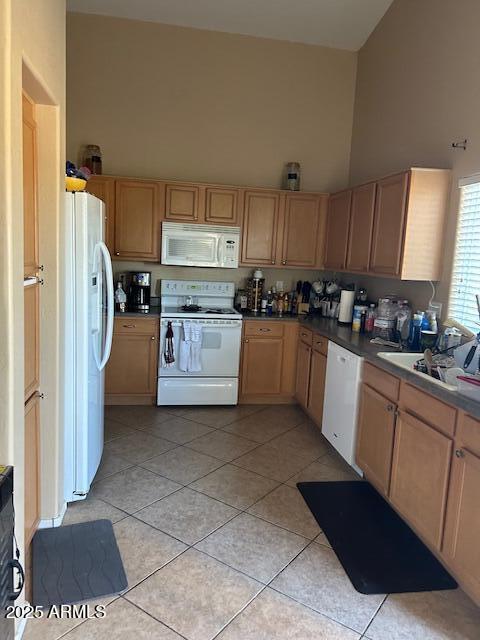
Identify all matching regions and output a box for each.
[400,383,457,436]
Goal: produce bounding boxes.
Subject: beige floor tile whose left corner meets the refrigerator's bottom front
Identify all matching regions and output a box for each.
[91,467,181,513]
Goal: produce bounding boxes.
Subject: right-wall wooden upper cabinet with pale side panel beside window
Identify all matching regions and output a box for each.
[325,168,451,280]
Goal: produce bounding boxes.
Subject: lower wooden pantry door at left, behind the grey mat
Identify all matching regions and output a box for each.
[24,394,40,547]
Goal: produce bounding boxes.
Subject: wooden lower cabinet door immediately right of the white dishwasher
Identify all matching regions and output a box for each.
[356,384,396,495]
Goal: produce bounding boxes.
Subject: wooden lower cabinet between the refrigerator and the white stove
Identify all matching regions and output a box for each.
[105,317,159,404]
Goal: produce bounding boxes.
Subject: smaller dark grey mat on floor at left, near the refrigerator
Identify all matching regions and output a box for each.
[32,520,128,607]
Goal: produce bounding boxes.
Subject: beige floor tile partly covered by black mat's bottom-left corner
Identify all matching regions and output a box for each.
[271,544,384,633]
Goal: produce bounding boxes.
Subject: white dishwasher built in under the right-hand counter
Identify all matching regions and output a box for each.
[322,341,363,474]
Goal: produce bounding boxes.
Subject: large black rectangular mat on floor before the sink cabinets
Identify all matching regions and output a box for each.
[297,481,458,594]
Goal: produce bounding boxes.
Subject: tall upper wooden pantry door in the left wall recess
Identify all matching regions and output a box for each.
[23,94,38,276]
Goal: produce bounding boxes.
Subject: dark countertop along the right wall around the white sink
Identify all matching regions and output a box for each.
[300,316,480,419]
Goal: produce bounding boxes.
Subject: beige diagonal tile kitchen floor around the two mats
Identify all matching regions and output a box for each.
[24,406,480,640]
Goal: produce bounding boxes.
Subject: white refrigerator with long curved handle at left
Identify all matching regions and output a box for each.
[75,194,113,497]
